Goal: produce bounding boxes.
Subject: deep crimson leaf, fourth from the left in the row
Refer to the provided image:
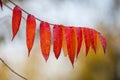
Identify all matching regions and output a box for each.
[53,25,63,59]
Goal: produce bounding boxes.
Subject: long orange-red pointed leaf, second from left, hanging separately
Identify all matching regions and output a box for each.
[26,14,36,56]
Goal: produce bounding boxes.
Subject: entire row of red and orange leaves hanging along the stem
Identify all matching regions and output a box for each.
[0,0,107,64]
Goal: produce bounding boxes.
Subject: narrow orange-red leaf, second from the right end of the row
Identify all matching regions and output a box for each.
[90,29,97,53]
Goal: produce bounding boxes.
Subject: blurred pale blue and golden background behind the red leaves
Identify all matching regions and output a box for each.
[0,0,120,80]
